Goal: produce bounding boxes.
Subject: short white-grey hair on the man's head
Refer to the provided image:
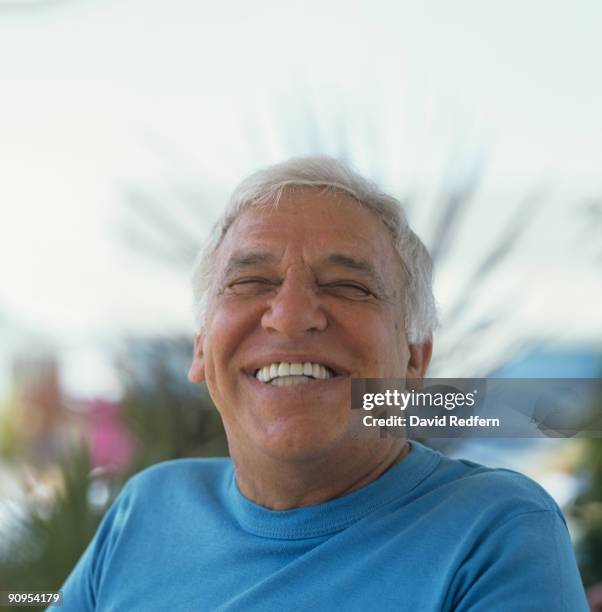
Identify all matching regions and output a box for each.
[192,155,437,344]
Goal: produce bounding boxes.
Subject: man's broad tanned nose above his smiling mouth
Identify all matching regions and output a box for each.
[261,270,328,338]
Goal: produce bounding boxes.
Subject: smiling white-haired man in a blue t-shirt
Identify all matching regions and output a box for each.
[54,157,587,612]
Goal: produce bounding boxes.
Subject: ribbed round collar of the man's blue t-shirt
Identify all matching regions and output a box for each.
[227,441,441,540]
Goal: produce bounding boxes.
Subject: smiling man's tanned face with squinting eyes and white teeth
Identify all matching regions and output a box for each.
[189,189,428,459]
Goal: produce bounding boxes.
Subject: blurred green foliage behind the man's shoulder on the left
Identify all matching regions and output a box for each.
[0,346,228,610]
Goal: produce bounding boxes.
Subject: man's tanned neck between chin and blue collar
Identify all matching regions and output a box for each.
[230,438,410,510]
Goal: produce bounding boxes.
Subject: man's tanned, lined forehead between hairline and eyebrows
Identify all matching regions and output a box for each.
[218,188,398,267]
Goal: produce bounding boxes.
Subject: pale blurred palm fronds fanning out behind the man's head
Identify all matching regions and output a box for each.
[121,92,546,377]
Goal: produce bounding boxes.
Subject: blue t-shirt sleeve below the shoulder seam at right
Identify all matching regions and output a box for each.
[451,510,589,612]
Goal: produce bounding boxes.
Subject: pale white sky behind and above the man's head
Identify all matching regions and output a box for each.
[0,0,602,392]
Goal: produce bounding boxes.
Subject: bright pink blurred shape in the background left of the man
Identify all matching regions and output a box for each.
[85,400,134,473]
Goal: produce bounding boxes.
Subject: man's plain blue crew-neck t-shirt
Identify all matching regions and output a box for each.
[51,442,588,612]
